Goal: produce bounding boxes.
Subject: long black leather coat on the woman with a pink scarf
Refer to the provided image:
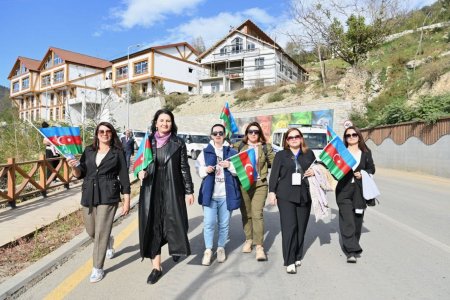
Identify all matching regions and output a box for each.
[139,135,194,258]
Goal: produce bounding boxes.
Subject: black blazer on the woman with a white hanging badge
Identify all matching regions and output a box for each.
[269,150,316,204]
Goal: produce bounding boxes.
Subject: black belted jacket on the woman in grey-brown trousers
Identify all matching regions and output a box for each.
[78,146,131,207]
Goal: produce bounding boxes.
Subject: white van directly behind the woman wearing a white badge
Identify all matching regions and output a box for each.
[272,124,327,160]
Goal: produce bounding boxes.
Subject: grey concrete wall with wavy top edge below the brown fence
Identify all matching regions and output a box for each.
[367,135,450,178]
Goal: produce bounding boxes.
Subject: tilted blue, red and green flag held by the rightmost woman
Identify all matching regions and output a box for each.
[319,136,356,181]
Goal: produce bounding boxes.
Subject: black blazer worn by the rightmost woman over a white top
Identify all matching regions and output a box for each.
[336,151,375,209]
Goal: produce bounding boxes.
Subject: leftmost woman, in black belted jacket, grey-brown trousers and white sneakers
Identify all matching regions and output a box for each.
[67,122,130,282]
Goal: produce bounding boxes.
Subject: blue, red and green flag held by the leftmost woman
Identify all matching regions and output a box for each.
[39,127,82,157]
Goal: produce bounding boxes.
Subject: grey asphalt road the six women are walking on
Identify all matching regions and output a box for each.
[20,161,450,299]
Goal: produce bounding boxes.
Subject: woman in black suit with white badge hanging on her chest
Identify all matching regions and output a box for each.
[269,128,316,274]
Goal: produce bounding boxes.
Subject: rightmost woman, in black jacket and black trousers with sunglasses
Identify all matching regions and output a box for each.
[336,126,375,263]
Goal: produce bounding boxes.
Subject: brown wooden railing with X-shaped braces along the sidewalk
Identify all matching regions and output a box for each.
[0,154,77,207]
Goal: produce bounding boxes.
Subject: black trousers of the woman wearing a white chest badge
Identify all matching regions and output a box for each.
[278,199,311,266]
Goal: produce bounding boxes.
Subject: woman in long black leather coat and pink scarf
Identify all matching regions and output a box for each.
[138,109,194,284]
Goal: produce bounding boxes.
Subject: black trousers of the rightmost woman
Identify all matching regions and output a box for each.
[338,199,364,255]
